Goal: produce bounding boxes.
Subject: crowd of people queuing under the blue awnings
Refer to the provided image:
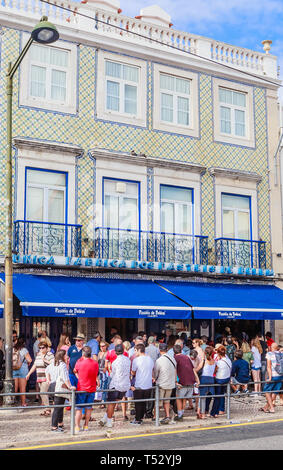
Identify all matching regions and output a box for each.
[7,329,283,433]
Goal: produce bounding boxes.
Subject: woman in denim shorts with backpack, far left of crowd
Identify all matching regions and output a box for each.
[13,336,32,406]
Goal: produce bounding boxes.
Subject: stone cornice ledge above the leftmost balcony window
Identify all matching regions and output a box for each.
[13,137,83,157]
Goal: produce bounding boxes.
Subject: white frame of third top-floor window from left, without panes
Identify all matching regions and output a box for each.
[152,64,199,137]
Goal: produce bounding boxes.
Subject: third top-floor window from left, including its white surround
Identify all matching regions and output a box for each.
[153,64,199,137]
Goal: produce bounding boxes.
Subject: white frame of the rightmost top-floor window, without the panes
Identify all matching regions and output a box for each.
[213,78,255,148]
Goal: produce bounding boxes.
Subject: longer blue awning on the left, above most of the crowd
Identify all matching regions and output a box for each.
[1,274,191,319]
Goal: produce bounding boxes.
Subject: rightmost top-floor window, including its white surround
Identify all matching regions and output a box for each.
[213,78,255,148]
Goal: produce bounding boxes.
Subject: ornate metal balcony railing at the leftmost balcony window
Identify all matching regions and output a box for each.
[14,220,82,257]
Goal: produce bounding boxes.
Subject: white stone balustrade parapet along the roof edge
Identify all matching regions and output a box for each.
[0,0,278,80]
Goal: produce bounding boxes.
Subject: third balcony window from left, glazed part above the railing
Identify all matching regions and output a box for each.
[160,185,193,235]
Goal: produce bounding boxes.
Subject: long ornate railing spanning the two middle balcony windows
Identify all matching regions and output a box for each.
[94,227,208,264]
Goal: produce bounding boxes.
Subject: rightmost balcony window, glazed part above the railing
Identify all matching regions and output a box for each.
[222,194,251,240]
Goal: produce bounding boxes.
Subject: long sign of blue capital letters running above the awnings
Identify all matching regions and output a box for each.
[13,255,274,277]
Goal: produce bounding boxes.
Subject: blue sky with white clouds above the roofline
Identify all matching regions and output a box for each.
[117,0,283,94]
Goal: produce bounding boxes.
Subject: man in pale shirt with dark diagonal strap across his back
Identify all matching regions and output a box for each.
[154,343,177,424]
